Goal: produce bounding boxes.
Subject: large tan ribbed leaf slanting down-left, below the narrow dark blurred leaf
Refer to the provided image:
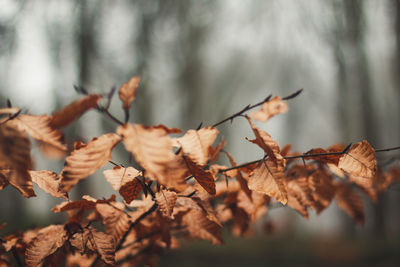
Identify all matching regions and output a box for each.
[60,133,121,192]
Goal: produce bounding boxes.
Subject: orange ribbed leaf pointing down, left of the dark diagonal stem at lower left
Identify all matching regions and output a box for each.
[96,202,131,243]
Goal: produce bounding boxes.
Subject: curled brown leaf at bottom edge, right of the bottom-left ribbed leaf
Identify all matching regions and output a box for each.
[69,226,115,265]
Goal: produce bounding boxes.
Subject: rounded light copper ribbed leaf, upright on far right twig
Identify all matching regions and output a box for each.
[338,140,376,179]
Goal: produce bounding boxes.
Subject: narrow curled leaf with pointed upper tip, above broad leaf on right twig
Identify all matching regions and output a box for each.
[246,116,282,160]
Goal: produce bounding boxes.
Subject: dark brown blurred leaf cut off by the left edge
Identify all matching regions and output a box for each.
[0,123,35,197]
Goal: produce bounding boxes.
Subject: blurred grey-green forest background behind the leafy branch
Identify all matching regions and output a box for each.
[0,0,400,266]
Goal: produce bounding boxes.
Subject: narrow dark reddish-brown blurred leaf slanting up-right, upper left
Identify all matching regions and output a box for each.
[50,94,101,129]
